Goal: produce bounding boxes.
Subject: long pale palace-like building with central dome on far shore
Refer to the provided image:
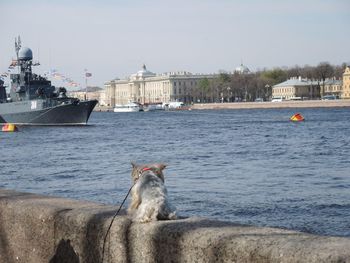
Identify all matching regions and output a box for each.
[104,65,215,106]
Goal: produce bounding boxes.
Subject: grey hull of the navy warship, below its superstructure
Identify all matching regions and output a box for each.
[0,100,97,125]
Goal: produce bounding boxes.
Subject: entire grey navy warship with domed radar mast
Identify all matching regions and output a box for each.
[0,39,97,125]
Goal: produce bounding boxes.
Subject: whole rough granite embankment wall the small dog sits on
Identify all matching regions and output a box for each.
[0,189,350,263]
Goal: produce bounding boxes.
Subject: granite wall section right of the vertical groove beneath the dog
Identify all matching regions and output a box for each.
[129,218,350,262]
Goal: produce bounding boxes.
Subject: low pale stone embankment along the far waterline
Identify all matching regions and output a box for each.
[94,100,350,111]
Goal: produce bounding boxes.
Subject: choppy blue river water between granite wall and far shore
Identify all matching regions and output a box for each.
[0,108,350,237]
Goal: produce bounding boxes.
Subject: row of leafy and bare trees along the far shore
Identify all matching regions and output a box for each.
[191,62,346,103]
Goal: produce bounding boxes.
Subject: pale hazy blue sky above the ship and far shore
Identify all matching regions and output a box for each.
[0,0,350,86]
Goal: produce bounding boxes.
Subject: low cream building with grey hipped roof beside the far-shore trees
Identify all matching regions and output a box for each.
[272,77,320,100]
